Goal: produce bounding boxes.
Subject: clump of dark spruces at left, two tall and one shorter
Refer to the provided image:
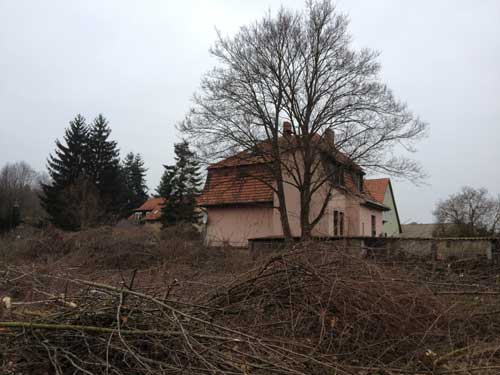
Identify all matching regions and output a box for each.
[40,115,148,230]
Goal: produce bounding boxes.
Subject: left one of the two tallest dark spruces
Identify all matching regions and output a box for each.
[40,115,89,230]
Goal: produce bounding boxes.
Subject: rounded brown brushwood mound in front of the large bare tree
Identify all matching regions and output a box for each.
[205,248,448,363]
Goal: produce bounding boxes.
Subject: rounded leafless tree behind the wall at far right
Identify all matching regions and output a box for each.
[434,186,500,237]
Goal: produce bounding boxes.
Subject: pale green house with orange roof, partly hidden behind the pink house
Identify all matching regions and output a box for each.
[365,178,402,237]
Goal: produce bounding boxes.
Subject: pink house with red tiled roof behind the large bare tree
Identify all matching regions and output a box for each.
[198,123,389,247]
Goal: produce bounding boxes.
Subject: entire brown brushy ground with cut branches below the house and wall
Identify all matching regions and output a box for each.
[0,226,500,374]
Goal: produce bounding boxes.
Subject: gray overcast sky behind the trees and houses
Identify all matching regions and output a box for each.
[0,0,500,222]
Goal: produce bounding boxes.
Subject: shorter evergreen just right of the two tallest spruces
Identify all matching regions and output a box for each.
[121,152,148,216]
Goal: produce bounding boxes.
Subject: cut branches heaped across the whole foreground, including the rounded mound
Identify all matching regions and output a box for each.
[0,244,497,375]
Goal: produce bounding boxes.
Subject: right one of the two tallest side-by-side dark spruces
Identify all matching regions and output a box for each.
[87,114,126,218]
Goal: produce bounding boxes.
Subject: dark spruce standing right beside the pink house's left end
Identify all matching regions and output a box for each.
[158,140,202,226]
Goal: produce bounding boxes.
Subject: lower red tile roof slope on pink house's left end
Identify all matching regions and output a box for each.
[198,164,273,206]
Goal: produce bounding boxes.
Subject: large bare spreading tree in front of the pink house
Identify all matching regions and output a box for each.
[181,1,426,237]
